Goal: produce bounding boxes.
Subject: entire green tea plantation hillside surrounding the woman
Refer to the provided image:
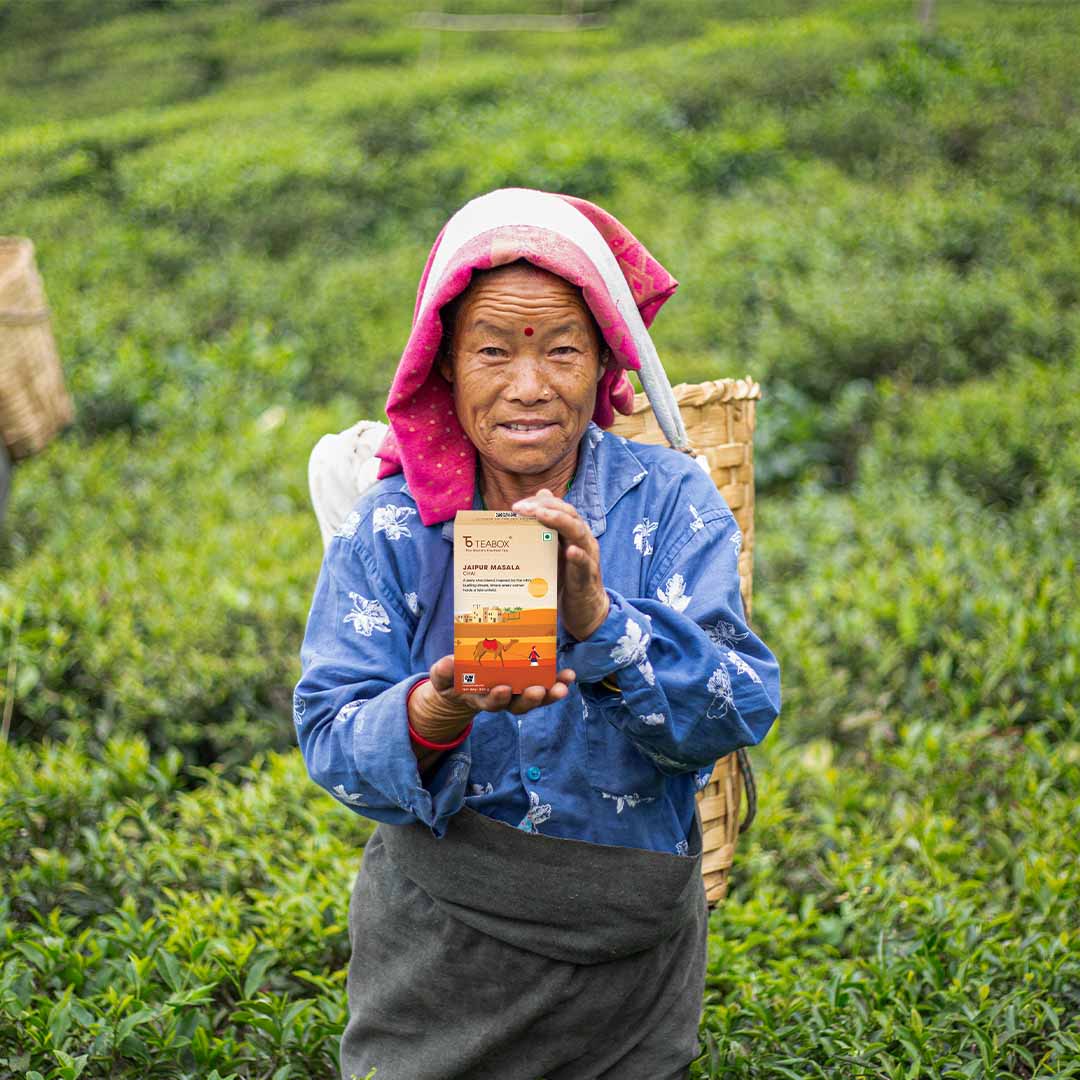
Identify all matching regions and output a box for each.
[0,0,1080,1080]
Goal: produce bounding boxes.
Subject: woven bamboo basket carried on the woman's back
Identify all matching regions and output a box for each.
[609,376,761,905]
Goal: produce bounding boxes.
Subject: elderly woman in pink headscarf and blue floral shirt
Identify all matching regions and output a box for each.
[295,188,780,1080]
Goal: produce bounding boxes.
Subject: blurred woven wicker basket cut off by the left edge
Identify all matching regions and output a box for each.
[0,237,73,459]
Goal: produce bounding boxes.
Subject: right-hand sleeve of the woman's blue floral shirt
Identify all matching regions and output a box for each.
[559,489,780,774]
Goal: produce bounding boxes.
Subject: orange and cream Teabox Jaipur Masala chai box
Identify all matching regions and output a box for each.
[454,510,558,693]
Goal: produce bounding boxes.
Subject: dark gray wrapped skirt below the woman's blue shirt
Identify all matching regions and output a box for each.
[341,808,708,1080]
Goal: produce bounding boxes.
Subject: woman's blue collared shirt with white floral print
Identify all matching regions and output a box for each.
[294,424,780,854]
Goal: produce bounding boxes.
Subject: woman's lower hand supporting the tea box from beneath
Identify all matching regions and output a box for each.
[408,653,577,742]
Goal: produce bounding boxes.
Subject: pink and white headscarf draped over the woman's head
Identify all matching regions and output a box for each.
[377,188,685,525]
